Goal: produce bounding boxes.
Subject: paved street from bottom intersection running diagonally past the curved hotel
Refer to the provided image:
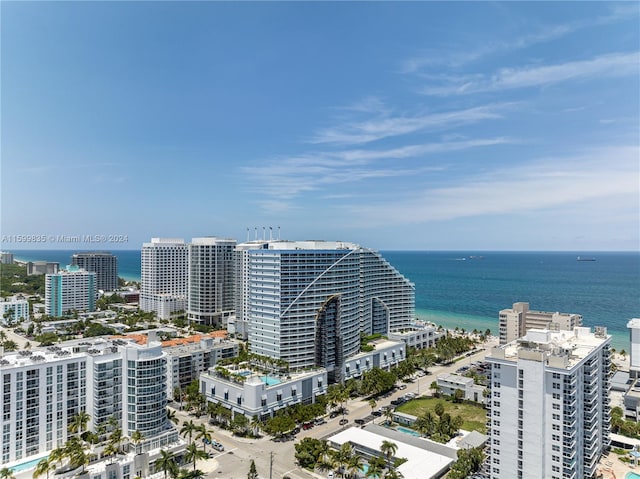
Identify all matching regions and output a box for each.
[172,340,498,479]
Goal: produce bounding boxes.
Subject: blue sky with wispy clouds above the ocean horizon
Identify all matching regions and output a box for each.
[0,2,640,251]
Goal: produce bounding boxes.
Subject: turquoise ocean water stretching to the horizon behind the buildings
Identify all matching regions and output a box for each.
[7,250,640,351]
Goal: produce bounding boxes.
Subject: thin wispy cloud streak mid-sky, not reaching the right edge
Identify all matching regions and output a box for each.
[310,103,513,145]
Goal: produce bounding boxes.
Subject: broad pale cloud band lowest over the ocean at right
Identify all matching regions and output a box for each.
[352,146,640,225]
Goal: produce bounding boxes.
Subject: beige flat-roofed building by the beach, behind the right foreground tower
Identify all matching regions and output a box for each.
[498,302,582,344]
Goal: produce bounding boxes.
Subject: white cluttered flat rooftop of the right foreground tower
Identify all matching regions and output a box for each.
[487,327,611,369]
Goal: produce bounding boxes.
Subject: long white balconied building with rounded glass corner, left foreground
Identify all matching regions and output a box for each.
[0,333,184,479]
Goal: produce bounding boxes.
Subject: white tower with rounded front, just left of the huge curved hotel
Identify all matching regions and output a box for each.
[187,237,236,326]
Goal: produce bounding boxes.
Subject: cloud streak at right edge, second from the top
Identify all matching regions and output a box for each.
[422,52,640,96]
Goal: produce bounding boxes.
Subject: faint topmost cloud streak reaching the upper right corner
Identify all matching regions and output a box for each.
[401,4,640,75]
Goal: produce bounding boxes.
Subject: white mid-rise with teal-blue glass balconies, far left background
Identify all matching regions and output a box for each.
[44,266,97,317]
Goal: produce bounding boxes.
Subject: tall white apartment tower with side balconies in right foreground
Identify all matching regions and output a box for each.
[486,327,611,479]
